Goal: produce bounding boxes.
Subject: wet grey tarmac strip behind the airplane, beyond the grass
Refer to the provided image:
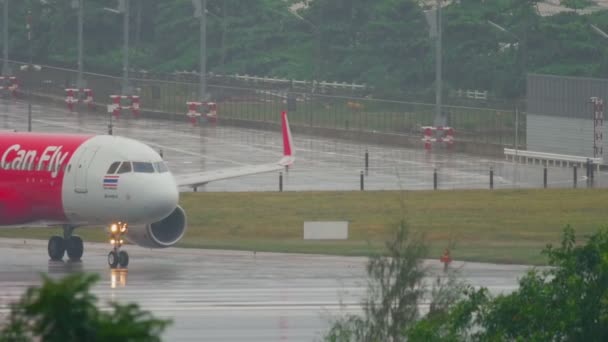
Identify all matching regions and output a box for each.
[0,101,606,191]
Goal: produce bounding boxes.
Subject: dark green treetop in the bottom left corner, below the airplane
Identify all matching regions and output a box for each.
[0,274,169,342]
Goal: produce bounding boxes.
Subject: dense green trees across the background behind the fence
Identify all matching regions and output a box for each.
[1,0,608,98]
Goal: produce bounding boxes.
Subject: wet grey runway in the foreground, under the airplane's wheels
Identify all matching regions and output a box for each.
[0,239,527,341]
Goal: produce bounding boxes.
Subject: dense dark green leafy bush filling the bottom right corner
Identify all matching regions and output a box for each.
[407,227,608,341]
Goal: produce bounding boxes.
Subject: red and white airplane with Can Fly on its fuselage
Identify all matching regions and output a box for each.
[0,112,295,268]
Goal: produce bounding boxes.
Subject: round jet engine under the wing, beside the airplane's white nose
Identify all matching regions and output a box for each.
[126,206,187,248]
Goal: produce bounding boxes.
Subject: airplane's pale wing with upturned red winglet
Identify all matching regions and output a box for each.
[175,112,295,189]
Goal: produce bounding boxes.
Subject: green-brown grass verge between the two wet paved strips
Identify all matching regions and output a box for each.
[0,189,608,264]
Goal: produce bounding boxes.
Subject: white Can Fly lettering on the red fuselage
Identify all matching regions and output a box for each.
[0,144,69,178]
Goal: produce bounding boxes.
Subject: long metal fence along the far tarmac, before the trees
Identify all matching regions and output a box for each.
[5,63,526,148]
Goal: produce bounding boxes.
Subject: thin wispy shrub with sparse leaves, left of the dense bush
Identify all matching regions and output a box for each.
[325,221,465,342]
